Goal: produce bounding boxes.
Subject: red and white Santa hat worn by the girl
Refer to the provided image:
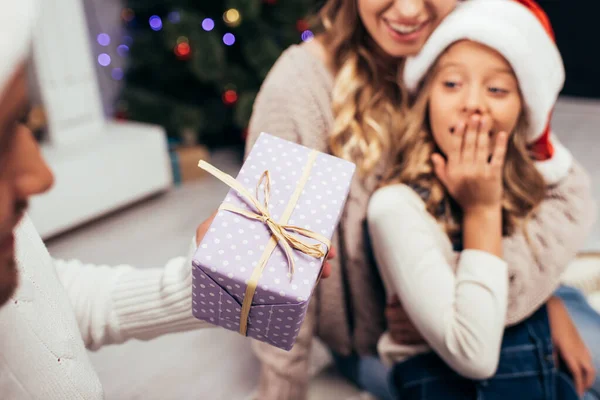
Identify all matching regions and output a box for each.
[404,0,572,183]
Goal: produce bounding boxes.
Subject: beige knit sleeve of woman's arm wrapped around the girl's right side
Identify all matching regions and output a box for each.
[503,162,597,325]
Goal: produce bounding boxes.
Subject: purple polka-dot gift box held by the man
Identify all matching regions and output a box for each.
[192,133,355,350]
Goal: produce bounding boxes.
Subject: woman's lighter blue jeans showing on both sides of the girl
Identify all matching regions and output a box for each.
[334,286,600,400]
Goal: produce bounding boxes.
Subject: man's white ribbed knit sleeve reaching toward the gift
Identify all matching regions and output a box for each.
[54,238,211,350]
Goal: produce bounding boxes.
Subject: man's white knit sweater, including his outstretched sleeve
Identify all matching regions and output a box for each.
[0,217,210,400]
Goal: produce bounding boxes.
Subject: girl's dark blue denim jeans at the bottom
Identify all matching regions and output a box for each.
[390,306,579,400]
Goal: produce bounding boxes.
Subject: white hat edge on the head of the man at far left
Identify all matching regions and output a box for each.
[0,0,36,93]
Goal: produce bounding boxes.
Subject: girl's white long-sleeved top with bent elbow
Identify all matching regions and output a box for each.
[368,184,508,379]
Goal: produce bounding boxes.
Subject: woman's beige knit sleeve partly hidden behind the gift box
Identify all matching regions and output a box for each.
[246,47,331,400]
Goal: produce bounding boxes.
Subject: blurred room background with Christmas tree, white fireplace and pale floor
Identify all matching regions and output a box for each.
[21,0,600,400]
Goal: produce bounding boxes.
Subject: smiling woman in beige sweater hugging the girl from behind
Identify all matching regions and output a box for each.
[247,0,593,400]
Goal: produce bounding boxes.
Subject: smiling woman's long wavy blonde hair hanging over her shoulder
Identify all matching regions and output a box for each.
[316,0,405,177]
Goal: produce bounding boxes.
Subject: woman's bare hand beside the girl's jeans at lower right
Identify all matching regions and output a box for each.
[547,297,596,396]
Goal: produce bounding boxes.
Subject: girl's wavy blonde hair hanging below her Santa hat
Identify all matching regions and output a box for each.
[381,62,546,241]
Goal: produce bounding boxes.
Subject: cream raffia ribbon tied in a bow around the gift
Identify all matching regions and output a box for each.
[198,150,331,336]
